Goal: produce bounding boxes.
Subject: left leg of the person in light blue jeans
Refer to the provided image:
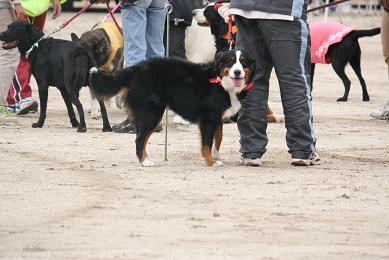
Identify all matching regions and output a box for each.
[121,0,151,67]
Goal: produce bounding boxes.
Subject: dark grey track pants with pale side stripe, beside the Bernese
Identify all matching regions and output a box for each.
[237,16,316,159]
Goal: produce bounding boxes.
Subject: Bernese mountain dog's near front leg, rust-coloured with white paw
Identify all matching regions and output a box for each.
[199,121,223,166]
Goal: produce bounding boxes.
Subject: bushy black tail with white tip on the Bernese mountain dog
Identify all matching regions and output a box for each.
[89,67,131,98]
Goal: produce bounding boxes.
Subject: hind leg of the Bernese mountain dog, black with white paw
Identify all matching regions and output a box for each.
[134,109,163,167]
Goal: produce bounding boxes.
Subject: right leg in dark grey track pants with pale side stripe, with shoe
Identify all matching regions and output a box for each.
[258,19,316,165]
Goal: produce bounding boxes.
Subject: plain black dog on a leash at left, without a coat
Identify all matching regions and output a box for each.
[0,21,111,132]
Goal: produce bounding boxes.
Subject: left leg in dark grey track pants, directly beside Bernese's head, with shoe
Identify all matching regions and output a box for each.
[236,17,273,166]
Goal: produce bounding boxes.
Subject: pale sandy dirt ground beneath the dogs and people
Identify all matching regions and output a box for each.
[0,9,389,259]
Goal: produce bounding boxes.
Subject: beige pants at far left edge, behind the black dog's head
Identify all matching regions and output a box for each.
[0,8,20,105]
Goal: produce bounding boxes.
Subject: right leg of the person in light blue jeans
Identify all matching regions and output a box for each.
[146,0,166,58]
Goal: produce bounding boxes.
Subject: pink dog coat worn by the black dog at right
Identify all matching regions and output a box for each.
[309,22,355,64]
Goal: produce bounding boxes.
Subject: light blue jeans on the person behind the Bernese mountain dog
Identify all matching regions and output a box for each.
[121,0,167,67]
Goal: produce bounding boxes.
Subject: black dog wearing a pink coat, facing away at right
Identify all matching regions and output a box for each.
[310,22,381,101]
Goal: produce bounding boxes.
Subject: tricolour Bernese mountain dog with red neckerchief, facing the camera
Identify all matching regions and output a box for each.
[90,50,254,166]
